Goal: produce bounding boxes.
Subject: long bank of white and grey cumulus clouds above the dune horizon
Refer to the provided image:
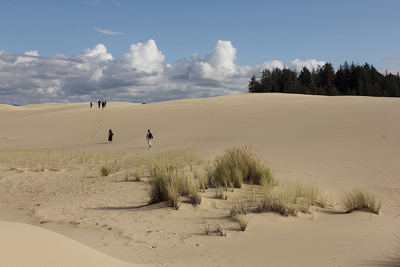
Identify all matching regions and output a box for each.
[0,39,324,105]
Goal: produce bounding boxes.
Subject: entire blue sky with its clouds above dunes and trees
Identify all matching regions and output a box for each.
[0,0,400,105]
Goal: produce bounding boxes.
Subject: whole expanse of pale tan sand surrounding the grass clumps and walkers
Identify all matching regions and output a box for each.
[0,94,400,266]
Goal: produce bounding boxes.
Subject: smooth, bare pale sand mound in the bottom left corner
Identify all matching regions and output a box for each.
[0,221,148,267]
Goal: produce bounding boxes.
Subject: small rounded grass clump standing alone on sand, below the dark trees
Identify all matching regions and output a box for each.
[344,187,383,215]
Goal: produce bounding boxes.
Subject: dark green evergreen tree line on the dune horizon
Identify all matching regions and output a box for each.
[248,61,400,97]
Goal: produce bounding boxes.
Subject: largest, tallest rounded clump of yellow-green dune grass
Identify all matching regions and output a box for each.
[211,146,276,188]
